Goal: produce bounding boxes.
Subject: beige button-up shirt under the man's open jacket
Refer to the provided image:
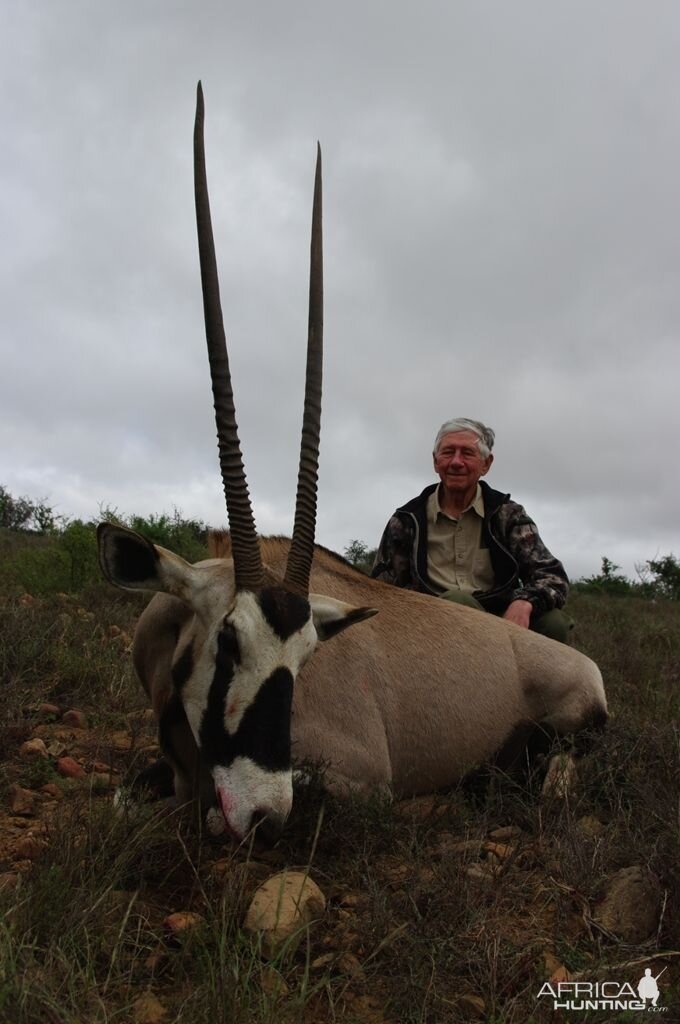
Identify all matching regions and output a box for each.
[427,484,496,594]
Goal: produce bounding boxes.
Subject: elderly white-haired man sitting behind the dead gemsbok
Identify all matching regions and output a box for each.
[372,418,573,643]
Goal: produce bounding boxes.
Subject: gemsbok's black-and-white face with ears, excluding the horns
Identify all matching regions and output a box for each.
[98,523,374,839]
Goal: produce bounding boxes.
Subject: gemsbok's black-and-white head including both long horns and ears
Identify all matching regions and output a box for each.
[98,84,375,839]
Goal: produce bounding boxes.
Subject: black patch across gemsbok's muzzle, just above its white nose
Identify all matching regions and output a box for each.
[200,668,293,771]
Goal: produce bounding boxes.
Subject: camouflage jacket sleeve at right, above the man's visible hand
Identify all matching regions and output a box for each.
[505,502,569,614]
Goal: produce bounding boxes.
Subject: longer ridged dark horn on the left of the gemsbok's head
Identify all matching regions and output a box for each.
[194,82,262,590]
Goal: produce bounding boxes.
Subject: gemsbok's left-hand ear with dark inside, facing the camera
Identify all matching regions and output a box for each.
[97,522,195,600]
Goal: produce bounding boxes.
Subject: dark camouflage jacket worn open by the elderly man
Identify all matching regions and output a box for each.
[371,480,568,616]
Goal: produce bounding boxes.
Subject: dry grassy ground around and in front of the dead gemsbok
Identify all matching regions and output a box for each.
[0,532,680,1024]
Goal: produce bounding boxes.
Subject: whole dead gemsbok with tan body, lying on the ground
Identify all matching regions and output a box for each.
[98,86,606,838]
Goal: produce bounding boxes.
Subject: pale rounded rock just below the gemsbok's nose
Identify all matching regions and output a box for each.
[244,871,326,958]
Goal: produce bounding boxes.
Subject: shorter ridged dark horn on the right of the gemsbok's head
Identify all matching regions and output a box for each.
[285,145,324,595]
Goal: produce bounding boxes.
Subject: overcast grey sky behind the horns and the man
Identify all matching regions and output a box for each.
[0,0,680,577]
